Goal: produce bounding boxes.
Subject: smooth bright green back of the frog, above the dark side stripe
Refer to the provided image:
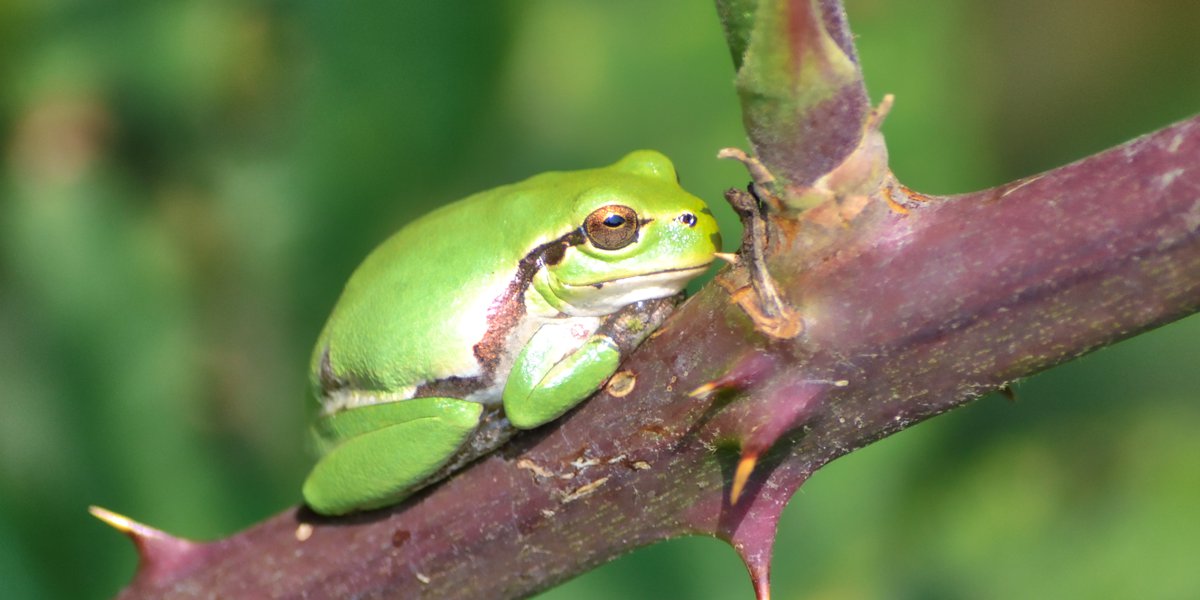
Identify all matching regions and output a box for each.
[313,173,578,397]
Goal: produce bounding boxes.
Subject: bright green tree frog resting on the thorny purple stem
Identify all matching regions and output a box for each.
[304,150,721,515]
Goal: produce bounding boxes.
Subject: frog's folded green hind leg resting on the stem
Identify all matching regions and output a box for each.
[304,397,484,515]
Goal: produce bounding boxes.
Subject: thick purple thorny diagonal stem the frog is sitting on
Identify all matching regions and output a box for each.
[110,112,1200,598]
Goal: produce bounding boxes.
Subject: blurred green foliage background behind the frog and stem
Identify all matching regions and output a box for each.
[0,0,1200,599]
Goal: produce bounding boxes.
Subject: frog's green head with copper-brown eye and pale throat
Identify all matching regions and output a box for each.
[535,150,721,314]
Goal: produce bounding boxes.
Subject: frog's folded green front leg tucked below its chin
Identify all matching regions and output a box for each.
[504,324,620,430]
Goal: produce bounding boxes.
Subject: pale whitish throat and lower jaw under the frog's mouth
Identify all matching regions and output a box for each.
[530,263,709,317]
